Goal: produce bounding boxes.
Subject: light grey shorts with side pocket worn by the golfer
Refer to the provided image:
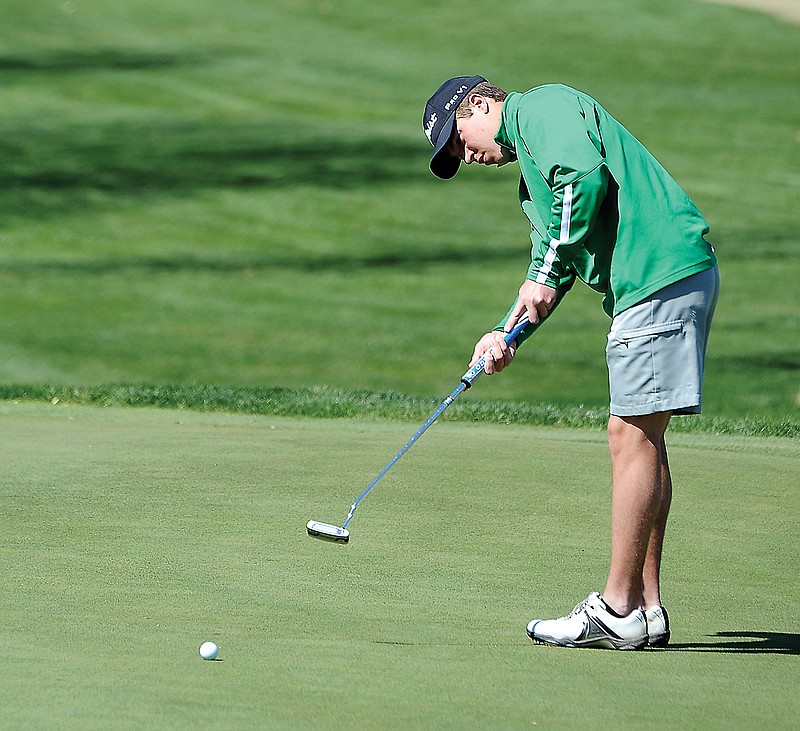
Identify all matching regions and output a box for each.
[606,266,719,416]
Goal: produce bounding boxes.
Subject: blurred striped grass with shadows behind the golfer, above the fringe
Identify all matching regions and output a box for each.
[0,0,800,423]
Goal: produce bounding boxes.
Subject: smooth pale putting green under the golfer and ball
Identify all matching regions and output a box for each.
[0,402,800,729]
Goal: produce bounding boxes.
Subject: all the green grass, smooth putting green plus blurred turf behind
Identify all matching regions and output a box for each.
[0,0,800,729]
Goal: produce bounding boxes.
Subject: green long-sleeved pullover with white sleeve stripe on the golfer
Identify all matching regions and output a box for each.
[495,84,716,339]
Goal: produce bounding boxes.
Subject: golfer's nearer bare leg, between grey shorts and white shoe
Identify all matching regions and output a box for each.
[603,412,670,615]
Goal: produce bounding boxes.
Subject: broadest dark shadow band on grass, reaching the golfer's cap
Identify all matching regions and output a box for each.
[0,119,427,215]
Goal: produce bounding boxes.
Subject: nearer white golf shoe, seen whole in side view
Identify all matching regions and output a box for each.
[528,592,647,650]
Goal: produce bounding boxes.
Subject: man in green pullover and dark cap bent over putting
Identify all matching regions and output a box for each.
[423,76,719,649]
